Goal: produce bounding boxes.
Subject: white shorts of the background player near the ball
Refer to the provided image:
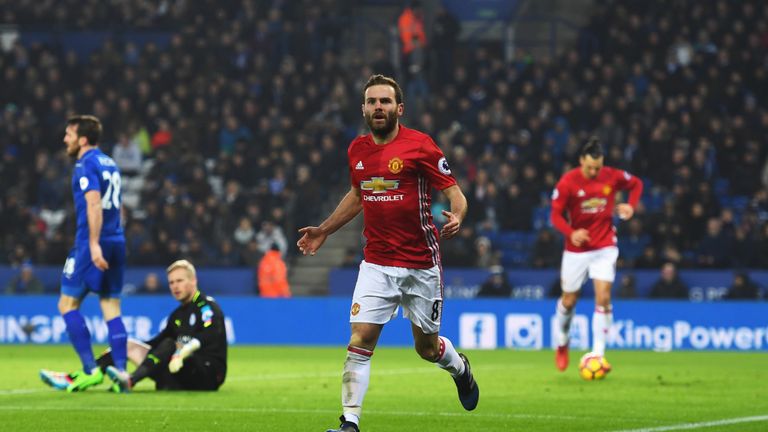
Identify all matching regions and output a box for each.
[560,246,619,293]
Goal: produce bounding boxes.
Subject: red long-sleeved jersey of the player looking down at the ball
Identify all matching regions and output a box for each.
[551,166,643,252]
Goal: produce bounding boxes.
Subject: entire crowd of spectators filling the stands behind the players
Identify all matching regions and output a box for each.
[0,0,768,284]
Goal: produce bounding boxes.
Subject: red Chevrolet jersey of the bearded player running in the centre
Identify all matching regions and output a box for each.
[347,125,456,269]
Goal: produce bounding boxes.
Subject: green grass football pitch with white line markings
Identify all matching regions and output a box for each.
[0,345,768,432]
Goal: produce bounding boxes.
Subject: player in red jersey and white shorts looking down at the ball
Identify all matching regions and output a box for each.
[552,137,643,371]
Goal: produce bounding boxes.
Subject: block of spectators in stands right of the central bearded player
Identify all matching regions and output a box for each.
[438,1,768,268]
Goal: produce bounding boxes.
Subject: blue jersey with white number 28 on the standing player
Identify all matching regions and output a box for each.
[72,148,125,246]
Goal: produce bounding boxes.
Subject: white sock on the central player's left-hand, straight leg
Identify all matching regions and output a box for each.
[341,345,373,424]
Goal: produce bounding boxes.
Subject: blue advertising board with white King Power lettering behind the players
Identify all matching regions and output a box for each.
[0,296,768,351]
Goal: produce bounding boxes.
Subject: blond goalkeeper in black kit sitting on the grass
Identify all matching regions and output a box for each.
[40,260,227,392]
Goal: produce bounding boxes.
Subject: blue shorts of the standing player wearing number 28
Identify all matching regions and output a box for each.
[61,241,125,299]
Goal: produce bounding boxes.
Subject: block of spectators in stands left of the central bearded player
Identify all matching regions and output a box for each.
[0,1,362,267]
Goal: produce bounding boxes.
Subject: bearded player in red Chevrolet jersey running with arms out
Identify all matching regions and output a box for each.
[297,75,480,432]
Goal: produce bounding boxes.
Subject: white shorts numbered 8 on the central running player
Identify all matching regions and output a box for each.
[349,261,443,334]
